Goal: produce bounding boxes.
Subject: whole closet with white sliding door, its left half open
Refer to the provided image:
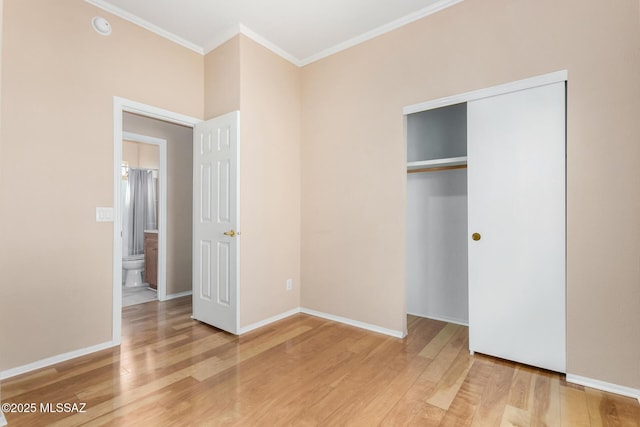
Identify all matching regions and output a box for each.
[404,72,566,372]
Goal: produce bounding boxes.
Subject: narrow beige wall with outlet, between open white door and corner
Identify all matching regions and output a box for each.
[240,36,301,326]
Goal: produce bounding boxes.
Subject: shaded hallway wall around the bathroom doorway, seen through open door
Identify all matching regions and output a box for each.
[122,113,193,295]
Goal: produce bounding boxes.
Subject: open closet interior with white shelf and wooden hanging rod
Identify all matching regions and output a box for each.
[406,103,469,325]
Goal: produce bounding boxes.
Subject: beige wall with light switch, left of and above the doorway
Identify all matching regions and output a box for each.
[0,0,204,370]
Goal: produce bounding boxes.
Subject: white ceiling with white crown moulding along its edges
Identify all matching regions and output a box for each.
[86,0,462,65]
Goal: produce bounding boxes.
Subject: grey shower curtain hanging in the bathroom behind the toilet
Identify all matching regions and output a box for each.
[122,168,158,255]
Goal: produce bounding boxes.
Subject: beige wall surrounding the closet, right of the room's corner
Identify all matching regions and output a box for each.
[302,0,640,388]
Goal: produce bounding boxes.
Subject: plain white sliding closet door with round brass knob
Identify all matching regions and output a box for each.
[467,82,566,372]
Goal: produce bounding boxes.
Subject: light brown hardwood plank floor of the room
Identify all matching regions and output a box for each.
[2,297,640,427]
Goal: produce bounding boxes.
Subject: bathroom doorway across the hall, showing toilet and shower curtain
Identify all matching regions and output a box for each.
[120,131,167,307]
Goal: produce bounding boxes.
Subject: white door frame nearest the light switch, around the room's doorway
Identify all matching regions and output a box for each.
[111,96,202,345]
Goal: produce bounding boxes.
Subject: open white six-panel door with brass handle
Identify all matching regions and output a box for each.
[193,111,240,334]
